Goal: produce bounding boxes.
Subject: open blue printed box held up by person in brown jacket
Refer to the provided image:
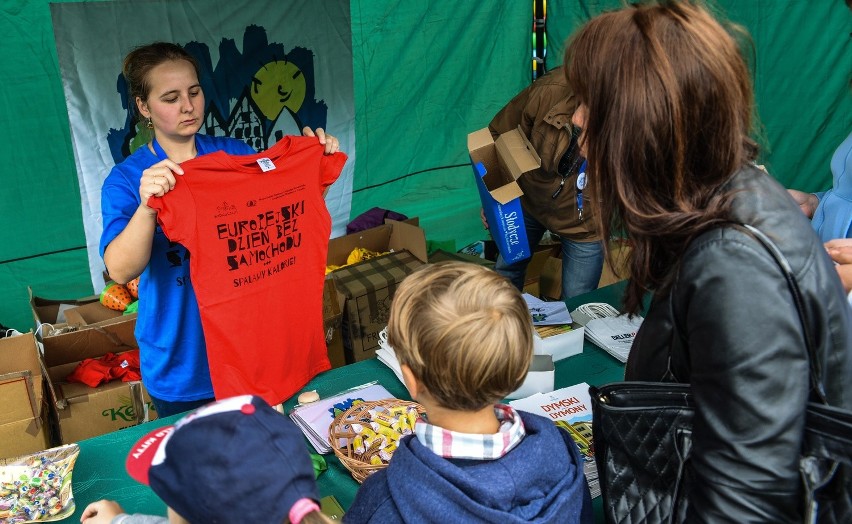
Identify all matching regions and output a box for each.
[467,128,541,263]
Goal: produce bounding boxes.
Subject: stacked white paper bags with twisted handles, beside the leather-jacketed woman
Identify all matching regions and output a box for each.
[571,303,644,362]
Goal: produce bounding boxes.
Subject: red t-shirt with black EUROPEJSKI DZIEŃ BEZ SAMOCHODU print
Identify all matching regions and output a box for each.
[148,136,346,405]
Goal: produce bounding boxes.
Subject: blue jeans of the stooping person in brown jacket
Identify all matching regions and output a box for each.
[494,215,603,300]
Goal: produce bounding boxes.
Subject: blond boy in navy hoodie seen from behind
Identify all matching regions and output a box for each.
[343,262,593,524]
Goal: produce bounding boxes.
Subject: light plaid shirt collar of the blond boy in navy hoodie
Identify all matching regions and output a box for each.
[414,404,527,460]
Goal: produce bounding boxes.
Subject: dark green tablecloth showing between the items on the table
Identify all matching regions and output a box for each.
[69,284,624,522]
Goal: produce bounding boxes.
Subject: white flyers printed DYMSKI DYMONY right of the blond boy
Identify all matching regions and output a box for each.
[509,382,601,497]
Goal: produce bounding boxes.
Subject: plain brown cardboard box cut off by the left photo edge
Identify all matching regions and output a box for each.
[0,332,51,458]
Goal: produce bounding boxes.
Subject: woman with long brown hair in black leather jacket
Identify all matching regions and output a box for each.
[564,2,852,523]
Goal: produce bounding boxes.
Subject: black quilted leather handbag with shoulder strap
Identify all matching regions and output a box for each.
[589,226,852,524]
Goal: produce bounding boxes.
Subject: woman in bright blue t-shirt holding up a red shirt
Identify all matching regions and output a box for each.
[100,42,340,417]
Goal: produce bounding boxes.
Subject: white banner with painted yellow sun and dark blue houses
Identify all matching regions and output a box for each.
[50,0,355,292]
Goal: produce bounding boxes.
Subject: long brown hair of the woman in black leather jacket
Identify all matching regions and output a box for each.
[564,1,757,314]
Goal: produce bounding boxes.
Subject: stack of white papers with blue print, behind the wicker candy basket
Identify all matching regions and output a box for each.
[290,382,394,453]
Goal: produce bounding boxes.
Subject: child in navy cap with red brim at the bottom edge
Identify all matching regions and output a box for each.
[80,395,332,524]
